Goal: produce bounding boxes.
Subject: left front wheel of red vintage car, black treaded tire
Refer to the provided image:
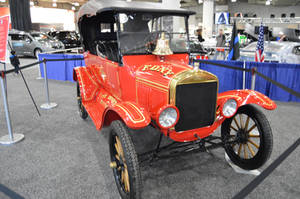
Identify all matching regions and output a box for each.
[109,120,142,199]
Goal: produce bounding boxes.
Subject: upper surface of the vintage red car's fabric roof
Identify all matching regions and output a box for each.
[77,0,195,19]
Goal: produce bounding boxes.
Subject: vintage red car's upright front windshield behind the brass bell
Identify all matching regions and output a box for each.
[119,13,188,55]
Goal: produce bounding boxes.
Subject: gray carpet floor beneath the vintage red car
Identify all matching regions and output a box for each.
[0,59,300,199]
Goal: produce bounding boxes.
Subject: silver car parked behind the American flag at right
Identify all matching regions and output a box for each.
[239,41,300,64]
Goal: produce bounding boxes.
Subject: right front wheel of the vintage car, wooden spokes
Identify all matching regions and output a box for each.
[221,105,273,170]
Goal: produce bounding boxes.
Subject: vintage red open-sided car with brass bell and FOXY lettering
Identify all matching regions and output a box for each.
[74,0,276,198]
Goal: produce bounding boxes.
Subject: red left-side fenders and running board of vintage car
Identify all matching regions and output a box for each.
[73,67,151,130]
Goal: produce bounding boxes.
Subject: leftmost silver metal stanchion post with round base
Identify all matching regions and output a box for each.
[0,76,25,145]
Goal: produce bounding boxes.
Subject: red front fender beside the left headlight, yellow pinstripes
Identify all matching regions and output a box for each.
[112,102,151,129]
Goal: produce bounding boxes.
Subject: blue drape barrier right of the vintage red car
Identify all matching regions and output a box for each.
[200,60,300,102]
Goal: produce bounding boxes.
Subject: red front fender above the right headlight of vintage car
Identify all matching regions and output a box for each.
[217,90,277,110]
